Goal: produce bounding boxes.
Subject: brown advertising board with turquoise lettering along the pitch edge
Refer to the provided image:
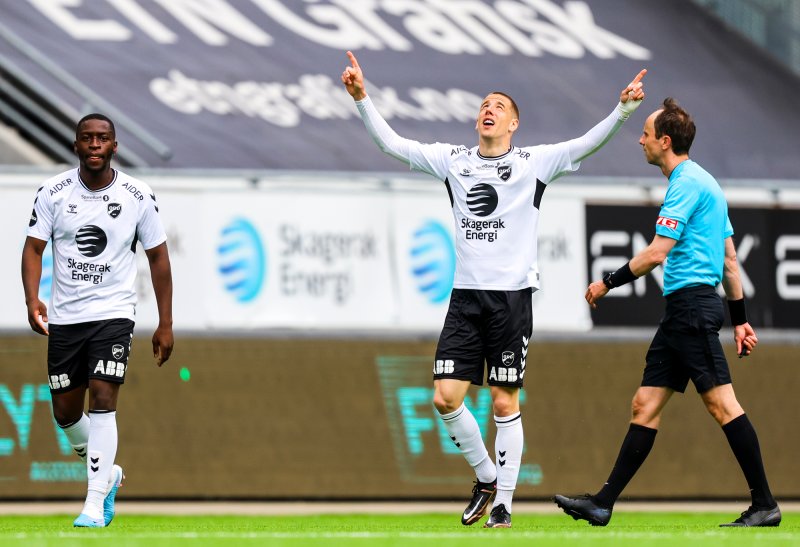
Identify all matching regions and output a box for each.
[0,334,800,500]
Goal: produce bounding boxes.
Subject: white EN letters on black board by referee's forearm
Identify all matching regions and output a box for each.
[589,230,664,298]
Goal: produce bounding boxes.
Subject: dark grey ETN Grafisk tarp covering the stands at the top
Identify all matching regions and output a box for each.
[0,0,797,179]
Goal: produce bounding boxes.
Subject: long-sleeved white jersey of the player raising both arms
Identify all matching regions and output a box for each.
[356,97,630,291]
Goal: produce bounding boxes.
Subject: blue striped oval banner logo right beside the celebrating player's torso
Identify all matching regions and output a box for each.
[409,220,456,304]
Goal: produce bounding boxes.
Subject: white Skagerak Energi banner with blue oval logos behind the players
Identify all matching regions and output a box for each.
[0,178,591,336]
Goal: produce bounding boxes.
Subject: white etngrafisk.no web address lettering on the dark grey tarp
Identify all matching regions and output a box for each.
[150,70,481,127]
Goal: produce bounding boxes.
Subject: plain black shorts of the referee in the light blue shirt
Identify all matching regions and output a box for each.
[642,285,731,393]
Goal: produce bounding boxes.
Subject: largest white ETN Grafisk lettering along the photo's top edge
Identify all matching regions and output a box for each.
[28,0,651,60]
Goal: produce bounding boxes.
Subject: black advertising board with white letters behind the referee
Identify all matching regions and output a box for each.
[586,204,800,329]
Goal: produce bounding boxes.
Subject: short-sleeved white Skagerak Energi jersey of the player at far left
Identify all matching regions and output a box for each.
[28,168,167,325]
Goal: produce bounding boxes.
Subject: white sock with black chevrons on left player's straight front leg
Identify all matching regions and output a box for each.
[82,411,117,519]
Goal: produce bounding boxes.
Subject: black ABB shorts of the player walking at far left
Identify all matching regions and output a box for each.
[47,319,134,393]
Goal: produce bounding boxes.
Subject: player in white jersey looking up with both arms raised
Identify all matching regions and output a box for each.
[342,51,647,528]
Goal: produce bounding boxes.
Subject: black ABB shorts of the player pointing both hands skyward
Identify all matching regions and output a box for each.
[433,288,533,387]
